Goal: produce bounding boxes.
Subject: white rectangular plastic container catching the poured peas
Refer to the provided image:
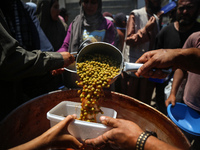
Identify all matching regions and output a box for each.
[47,101,117,141]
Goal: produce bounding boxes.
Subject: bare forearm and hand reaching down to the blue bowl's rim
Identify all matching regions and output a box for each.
[165,69,187,106]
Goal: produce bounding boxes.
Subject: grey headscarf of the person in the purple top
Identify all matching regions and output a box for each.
[69,0,105,52]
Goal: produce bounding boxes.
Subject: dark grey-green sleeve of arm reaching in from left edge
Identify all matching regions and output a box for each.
[0,23,64,80]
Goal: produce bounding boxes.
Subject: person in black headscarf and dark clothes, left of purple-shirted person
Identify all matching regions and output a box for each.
[36,0,67,94]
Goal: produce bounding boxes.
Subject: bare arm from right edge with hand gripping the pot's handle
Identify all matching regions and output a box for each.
[136,48,200,78]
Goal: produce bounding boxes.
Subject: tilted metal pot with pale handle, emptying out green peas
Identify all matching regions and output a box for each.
[65,40,172,84]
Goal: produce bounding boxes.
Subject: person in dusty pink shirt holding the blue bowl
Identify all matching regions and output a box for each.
[165,31,200,112]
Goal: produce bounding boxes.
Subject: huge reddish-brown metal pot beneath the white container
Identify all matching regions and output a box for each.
[0,90,190,149]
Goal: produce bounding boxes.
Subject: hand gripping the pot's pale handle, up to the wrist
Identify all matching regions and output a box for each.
[135,49,176,79]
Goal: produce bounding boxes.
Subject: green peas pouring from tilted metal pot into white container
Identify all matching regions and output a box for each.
[76,54,120,122]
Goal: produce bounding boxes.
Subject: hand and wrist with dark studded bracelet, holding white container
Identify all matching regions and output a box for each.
[85,116,181,150]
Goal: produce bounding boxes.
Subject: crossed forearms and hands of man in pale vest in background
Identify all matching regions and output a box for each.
[126,13,156,46]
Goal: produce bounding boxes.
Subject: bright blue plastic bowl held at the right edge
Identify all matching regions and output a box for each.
[167,103,200,141]
